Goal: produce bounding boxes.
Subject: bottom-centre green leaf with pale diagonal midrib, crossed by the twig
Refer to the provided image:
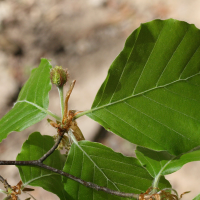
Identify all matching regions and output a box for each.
[63,141,171,200]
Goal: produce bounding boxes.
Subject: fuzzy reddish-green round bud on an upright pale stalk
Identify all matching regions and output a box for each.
[50,66,68,87]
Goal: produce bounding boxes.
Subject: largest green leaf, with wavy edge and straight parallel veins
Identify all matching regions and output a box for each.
[86,19,200,155]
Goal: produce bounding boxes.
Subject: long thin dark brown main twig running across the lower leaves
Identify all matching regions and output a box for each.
[0,160,139,198]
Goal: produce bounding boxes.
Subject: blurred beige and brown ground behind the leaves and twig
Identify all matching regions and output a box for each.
[0,0,200,200]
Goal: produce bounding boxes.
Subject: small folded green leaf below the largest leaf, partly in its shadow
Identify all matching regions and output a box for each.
[135,147,200,177]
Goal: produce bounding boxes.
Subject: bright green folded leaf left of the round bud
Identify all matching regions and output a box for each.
[0,59,52,142]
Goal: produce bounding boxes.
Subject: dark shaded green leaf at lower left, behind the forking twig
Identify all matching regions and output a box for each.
[16,132,68,200]
